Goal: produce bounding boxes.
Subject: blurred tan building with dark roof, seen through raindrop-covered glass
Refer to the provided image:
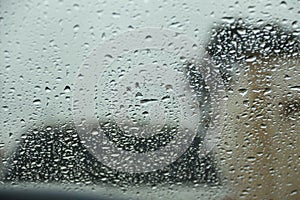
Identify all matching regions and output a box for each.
[206,20,300,199]
